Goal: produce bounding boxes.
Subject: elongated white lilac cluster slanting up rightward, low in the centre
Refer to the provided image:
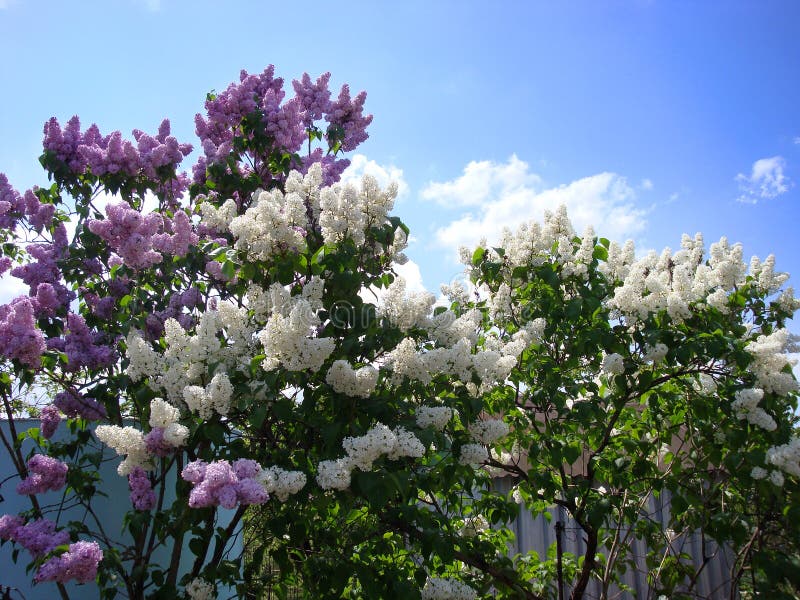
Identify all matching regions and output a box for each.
[317,423,425,490]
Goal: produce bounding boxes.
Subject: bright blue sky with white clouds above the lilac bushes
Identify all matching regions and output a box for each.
[0,0,800,300]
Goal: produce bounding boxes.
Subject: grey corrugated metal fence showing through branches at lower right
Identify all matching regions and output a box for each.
[494,478,733,600]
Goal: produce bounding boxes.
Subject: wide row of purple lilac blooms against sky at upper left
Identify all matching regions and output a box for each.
[43,117,192,180]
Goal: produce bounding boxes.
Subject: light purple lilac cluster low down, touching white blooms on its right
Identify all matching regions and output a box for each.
[181,459,269,508]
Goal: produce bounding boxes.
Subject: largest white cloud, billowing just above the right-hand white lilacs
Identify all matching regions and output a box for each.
[421,156,646,258]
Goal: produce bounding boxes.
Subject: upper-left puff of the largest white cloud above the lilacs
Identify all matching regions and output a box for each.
[420,154,542,207]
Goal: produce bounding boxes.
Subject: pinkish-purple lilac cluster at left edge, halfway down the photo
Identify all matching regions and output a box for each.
[0,297,46,369]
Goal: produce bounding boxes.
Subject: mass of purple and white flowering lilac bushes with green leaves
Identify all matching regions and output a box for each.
[0,67,800,600]
